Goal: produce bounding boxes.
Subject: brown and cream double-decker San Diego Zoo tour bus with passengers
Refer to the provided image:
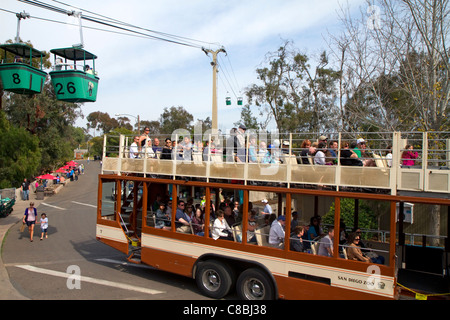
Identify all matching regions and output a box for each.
[96,130,450,300]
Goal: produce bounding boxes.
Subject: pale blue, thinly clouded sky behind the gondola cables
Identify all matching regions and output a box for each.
[0,0,365,135]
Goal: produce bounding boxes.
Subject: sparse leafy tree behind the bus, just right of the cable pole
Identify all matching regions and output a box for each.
[246,41,340,132]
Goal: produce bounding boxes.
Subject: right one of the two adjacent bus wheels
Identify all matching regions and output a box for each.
[236,268,275,300]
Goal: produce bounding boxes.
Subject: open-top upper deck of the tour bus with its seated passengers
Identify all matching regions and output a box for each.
[102,132,450,199]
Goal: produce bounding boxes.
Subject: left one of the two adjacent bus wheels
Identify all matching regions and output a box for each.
[195,261,233,299]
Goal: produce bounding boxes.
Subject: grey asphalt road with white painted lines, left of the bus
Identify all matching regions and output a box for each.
[2,161,207,300]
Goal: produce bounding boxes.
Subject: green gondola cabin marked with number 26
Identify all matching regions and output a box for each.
[50,47,99,102]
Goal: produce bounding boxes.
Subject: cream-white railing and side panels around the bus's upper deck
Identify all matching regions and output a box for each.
[102,132,450,197]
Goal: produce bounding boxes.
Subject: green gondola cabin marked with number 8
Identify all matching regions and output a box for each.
[0,43,47,94]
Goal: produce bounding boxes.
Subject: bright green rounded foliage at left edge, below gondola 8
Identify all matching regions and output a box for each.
[0,111,41,189]
